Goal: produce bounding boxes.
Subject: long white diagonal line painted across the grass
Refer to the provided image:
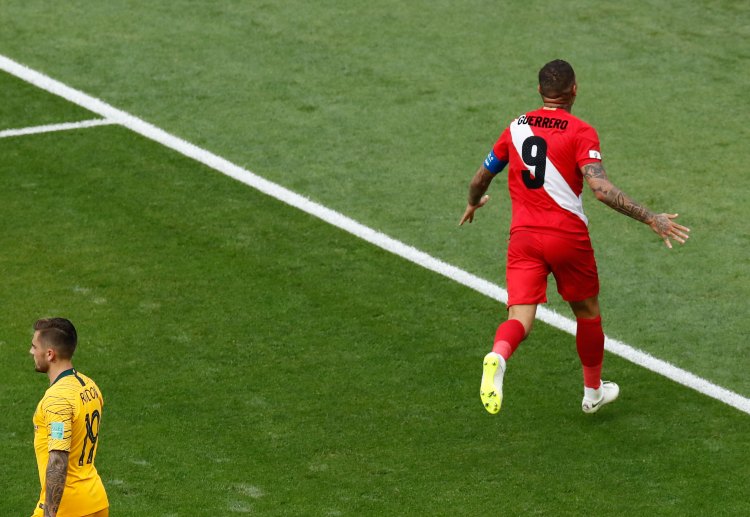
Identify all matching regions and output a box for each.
[0,55,750,414]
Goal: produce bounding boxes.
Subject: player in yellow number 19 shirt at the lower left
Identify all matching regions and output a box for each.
[29,318,109,517]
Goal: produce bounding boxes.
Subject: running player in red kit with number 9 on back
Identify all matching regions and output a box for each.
[459,59,690,414]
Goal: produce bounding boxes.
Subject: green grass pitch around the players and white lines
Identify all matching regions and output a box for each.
[0,1,750,516]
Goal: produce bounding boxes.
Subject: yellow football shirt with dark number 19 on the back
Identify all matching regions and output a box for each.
[32,369,109,517]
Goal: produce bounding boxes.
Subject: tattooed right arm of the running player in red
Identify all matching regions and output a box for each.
[582,162,690,248]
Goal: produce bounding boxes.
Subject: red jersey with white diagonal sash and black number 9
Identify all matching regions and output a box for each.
[491,108,602,237]
